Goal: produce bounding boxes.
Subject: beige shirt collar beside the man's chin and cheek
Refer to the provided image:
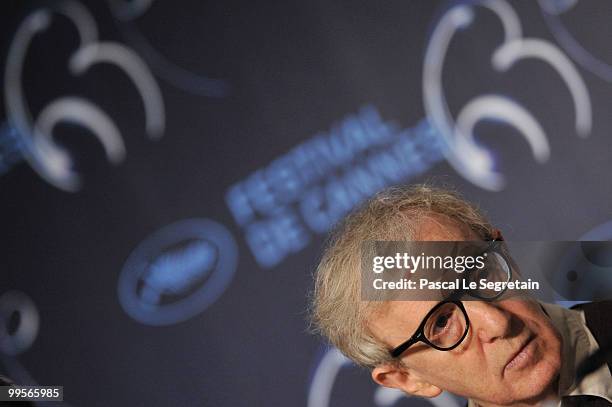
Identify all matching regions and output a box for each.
[468,303,612,407]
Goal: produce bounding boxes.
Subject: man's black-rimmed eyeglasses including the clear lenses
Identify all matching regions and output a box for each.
[390,240,512,358]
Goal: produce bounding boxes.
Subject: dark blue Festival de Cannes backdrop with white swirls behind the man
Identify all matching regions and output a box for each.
[0,0,612,407]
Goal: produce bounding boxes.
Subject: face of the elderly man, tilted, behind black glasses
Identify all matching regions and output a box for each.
[369,217,561,404]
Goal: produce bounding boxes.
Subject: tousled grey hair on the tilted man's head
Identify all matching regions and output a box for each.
[310,184,494,368]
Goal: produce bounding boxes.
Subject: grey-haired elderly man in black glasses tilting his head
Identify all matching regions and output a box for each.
[312,185,612,406]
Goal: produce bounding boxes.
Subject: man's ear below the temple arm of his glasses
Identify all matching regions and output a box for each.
[372,363,442,397]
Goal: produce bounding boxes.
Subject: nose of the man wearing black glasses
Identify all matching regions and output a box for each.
[468,301,512,343]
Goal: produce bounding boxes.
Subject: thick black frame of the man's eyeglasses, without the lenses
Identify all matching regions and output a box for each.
[389,238,512,358]
